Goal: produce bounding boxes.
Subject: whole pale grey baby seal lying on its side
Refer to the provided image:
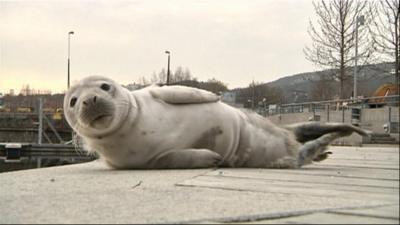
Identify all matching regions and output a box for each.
[64,76,366,169]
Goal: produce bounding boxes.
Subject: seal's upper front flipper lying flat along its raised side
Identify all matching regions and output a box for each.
[150,85,219,104]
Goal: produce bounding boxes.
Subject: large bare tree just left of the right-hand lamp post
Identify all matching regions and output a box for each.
[303,0,374,98]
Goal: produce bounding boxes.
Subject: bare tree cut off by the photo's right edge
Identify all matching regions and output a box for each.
[370,0,400,94]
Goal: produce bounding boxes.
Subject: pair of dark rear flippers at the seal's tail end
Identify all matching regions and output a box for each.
[286,122,368,166]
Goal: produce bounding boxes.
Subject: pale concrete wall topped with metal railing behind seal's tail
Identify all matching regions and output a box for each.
[257,95,399,133]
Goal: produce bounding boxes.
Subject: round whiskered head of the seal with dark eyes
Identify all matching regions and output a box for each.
[64,76,132,138]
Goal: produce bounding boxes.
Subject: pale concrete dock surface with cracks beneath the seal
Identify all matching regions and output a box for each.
[0,146,399,224]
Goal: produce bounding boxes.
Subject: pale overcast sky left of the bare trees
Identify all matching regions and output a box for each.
[0,0,316,93]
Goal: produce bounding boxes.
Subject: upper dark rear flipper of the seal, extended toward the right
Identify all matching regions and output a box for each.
[285,122,368,143]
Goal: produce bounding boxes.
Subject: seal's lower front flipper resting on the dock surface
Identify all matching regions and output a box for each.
[150,148,222,169]
